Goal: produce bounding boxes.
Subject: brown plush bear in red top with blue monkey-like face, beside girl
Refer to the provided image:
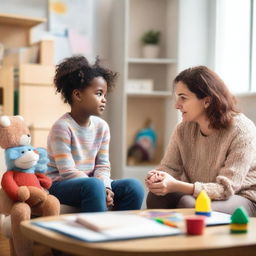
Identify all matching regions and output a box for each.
[0,116,60,256]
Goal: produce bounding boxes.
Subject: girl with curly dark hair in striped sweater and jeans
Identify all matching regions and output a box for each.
[48,56,144,212]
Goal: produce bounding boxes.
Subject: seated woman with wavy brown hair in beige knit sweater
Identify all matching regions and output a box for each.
[145,66,256,216]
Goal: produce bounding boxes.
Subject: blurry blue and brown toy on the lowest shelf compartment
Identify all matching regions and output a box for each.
[128,119,157,165]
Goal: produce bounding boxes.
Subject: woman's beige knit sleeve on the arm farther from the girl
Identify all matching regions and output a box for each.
[193,132,256,200]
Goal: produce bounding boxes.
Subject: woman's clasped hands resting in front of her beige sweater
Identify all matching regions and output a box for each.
[145,171,179,196]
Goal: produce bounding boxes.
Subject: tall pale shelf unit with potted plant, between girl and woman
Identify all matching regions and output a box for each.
[108,0,179,180]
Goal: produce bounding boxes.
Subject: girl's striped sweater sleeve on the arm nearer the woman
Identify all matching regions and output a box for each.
[93,125,111,188]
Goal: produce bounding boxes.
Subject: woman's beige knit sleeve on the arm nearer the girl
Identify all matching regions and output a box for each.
[156,126,183,179]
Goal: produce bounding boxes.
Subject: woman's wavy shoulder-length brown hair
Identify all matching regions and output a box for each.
[173,66,239,129]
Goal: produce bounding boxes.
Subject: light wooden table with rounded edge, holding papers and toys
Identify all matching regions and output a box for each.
[21,209,256,256]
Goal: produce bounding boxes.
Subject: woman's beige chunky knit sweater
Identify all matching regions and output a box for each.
[156,114,256,202]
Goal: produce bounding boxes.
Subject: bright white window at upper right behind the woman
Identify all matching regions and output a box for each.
[215,0,252,93]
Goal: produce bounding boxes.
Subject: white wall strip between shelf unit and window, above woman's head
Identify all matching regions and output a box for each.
[178,0,214,71]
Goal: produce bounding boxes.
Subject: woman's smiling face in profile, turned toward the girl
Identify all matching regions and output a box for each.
[175,82,209,123]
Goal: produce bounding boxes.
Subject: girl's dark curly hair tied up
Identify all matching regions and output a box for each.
[54,55,117,104]
